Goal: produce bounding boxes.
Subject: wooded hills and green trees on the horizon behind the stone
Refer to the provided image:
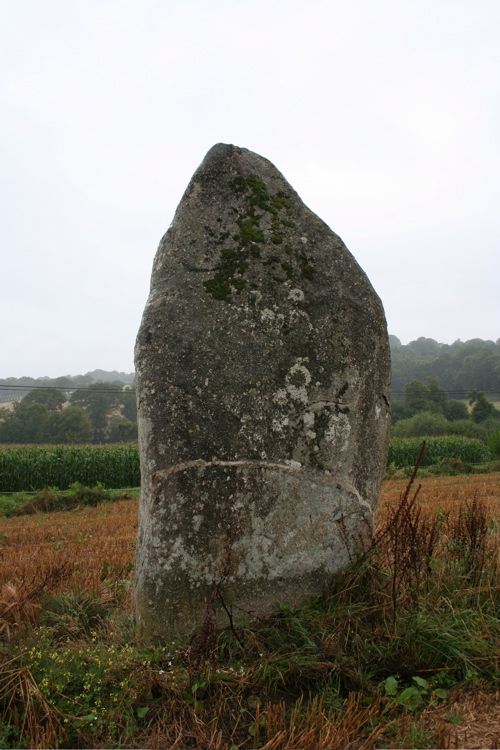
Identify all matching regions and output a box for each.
[0,336,500,443]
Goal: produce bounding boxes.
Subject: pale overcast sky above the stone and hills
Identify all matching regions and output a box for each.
[0,0,500,377]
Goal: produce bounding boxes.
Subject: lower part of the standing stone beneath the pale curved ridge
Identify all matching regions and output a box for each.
[136,461,373,639]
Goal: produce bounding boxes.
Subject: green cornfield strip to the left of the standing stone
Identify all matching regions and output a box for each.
[0,443,140,492]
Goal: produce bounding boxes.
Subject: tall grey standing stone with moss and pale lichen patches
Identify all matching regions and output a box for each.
[136,144,390,637]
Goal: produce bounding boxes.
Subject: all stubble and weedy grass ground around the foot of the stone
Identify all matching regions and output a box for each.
[0,474,500,750]
